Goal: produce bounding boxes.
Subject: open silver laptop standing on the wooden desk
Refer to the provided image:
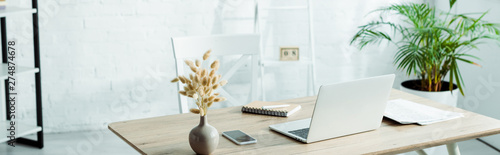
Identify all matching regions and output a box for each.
[269,74,395,143]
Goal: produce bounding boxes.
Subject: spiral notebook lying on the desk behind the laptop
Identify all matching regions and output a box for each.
[241,101,301,117]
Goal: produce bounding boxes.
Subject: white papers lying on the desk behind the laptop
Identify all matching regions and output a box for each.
[384,99,463,125]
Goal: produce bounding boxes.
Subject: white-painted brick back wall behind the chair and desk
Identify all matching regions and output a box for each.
[7,0,422,132]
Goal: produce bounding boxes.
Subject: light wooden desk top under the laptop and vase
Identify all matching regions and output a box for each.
[108,90,500,155]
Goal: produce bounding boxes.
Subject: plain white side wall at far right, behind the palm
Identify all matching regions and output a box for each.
[436,0,500,148]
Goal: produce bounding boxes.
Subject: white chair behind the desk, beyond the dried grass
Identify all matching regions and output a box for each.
[172,34,262,113]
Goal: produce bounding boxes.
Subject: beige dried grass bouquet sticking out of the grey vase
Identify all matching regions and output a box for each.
[171,50,227,116]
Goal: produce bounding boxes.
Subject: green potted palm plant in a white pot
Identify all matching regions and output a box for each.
[351,0,500,106]
